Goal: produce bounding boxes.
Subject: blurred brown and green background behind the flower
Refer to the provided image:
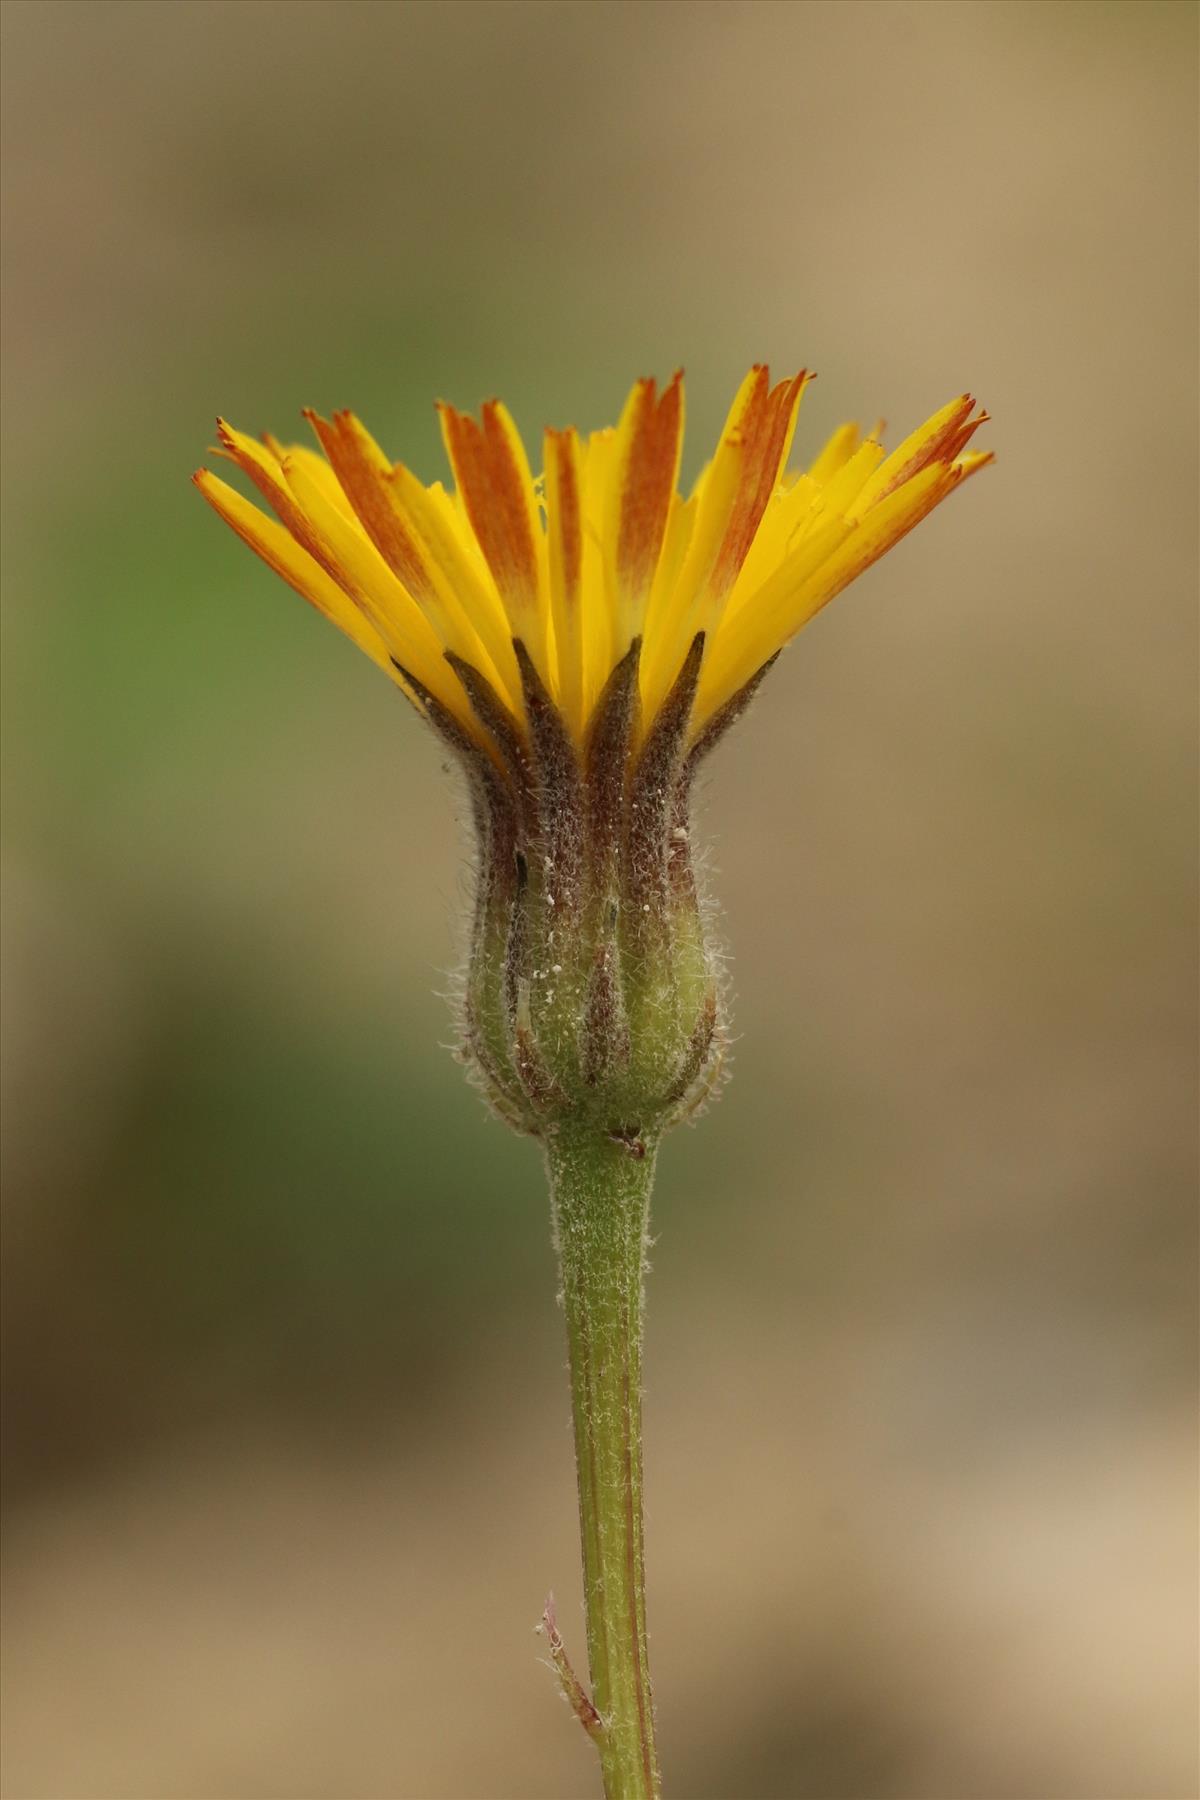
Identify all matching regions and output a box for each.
[4,0,1196,1800]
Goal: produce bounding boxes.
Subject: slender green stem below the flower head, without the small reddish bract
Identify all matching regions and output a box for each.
[547,1121,662,1800]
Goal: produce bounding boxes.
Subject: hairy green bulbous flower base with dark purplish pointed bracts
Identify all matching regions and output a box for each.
[455,634,723,1154]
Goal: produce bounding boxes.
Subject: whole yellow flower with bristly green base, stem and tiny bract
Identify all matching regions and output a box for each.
[196,367,990,1800]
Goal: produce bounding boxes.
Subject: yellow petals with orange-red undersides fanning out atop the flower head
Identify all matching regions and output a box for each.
[194,365,991,747]
